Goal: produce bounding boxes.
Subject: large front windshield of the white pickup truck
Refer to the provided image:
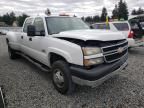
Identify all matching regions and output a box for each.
[46,17,90,34]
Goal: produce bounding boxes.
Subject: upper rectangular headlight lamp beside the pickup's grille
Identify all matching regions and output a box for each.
[82,47,102,56]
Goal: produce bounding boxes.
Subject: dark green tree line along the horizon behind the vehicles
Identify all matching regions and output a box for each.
[0,0,144,26]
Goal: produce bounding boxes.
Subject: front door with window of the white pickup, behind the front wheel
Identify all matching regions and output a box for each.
[28,17,47,64]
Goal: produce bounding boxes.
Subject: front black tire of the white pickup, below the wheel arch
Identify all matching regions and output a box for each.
[52,61,75,94]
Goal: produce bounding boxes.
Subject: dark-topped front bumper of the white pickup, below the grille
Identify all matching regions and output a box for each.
[70,54,128,86]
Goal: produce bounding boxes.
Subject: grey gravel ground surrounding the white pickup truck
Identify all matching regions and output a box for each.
[0,36,144,108]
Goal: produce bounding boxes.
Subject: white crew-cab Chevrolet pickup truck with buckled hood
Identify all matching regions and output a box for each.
[6,16,128,94]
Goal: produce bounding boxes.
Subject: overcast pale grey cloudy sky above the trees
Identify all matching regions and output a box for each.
[0,0,144,17]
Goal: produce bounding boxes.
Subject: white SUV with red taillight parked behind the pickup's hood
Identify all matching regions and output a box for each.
[92,21,135,47]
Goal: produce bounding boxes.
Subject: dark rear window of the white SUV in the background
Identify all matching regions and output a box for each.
[113,23,129,31]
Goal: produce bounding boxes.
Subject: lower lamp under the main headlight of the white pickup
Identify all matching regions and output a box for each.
[84,57,104,66]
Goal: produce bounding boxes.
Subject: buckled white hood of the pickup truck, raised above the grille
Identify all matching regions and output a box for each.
[53,30,126,41]
